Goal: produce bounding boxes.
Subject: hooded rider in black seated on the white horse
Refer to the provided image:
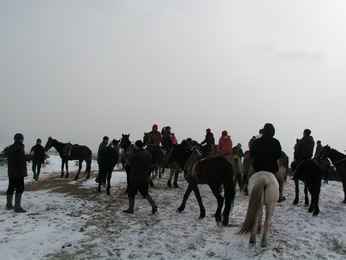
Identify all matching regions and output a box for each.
[250,123,286,202]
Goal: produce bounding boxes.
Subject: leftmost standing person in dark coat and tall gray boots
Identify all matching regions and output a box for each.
[6,133,29,213]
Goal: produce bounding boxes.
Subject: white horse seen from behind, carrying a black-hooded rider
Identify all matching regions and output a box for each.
[239,171,279,247]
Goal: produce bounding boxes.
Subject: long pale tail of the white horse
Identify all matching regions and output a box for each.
[238,176,269,234]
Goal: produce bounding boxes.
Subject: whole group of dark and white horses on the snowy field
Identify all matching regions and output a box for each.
[45,134,346,247]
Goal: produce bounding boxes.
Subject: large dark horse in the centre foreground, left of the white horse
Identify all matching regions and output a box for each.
[169,140,235,226]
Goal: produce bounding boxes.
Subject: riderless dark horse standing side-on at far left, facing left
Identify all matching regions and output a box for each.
[45,137,92,180]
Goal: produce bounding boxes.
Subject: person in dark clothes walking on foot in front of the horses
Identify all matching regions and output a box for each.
[124,140,157,214]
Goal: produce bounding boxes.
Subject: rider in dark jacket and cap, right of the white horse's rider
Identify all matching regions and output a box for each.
[292,129,315,166]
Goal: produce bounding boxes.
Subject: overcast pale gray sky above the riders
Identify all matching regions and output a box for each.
[0,0,346,156]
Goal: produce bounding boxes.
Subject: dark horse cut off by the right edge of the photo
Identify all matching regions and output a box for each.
[321,145,346,203]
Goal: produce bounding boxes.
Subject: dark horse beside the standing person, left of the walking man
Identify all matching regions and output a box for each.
[97,139,120,195]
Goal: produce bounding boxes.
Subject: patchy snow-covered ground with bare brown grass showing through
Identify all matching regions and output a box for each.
[0,154,346,259]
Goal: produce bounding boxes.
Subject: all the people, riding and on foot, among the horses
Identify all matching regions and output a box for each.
[6,123,321,213]
